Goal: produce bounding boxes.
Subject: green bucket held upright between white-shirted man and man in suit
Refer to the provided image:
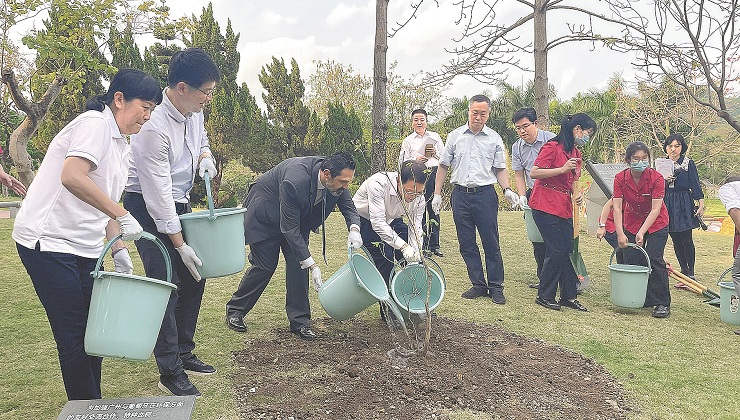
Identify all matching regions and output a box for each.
[180,171,247,278]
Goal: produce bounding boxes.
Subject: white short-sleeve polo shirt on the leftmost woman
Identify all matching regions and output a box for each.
[13,106,131,258]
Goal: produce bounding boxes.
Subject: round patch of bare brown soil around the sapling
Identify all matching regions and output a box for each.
[234,317,631,419]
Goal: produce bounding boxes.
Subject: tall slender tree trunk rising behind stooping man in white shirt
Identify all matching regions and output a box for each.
[371,0,389,173]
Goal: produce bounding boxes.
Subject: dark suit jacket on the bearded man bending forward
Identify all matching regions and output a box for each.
[244,156,360,261]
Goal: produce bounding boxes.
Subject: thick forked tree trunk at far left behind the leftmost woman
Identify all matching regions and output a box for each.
[2,69,66,188]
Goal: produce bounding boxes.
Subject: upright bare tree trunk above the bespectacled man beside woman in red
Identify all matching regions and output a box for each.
[534,0,550,130]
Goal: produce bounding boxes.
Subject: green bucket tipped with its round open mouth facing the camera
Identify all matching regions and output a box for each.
[390,264,445,314]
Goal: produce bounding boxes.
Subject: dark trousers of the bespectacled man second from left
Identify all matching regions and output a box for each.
[123,192,206,376]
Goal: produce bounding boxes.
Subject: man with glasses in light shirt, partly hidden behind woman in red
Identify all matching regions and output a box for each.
[511,108,555,289]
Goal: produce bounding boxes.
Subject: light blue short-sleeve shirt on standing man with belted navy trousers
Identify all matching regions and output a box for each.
[440,124,506,187]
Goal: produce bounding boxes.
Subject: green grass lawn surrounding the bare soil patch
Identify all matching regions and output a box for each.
[0,212,740,419]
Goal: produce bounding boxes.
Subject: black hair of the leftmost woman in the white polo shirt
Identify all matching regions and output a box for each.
[85,69,162,112]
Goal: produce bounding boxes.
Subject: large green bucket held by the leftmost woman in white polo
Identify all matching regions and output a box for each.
[85,232,177,360]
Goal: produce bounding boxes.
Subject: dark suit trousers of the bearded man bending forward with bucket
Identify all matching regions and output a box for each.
[226,231,311,331]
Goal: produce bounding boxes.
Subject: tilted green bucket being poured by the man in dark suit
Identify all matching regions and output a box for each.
[319,249,390,321]
